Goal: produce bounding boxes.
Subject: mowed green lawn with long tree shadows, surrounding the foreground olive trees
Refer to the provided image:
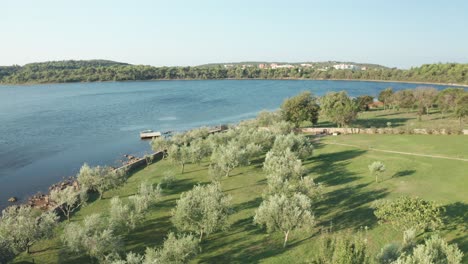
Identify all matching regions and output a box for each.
[17,135,468,263]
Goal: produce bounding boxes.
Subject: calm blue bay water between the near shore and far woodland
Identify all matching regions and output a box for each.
[0,80,454,207]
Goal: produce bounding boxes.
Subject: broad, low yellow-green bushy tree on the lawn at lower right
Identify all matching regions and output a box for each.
[374,197,442,235]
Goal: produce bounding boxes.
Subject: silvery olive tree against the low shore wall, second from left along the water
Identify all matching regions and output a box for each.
[77,163,127,199]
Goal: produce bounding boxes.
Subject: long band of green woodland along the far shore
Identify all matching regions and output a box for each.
[0,60,468,84]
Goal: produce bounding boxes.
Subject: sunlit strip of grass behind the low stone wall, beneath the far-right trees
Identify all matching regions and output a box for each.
[318,109,468,129]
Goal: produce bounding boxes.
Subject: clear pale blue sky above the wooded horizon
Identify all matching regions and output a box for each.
[0,0,468,68]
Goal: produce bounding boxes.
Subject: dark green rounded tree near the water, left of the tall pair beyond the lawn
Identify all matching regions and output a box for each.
[281,91,320,127]
